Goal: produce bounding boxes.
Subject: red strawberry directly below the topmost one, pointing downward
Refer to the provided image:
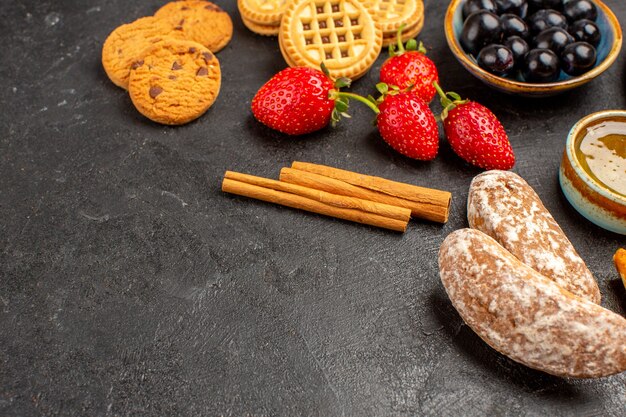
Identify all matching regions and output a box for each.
[376,84,439,161]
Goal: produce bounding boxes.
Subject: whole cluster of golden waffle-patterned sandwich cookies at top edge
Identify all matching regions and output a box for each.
[238,0,424,80]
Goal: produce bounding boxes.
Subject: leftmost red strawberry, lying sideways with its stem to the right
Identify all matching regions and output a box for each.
[252,67,350,135]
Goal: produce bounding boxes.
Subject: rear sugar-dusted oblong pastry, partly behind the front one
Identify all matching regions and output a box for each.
[467,171,600,303]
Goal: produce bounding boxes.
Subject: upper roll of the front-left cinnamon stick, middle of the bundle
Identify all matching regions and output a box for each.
[224,171,411,222]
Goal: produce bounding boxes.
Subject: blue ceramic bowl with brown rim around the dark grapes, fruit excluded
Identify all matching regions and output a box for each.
[444,0,622,97]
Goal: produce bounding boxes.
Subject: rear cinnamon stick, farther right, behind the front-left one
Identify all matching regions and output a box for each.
[281,161,452,223]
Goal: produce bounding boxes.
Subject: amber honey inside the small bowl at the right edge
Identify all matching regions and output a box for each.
[575,118,626,197]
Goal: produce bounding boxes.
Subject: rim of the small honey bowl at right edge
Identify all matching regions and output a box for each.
[565,110,626,203]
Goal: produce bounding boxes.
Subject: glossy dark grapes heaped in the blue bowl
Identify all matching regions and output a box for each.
[460,0,602,83]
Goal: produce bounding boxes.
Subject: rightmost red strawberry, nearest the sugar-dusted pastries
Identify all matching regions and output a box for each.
[435,84,515,170]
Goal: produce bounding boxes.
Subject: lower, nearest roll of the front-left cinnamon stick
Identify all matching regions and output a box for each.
[222,174,408,232]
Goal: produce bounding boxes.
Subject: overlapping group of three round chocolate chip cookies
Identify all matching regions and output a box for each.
[102,0,233,125]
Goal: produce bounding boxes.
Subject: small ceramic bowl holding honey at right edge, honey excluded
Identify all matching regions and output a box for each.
[559,110,626,235]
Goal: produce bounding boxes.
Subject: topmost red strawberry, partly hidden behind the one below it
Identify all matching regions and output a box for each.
[380,32,439,103]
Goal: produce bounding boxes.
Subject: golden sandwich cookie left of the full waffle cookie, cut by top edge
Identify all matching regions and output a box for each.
[237,0,287,36]
